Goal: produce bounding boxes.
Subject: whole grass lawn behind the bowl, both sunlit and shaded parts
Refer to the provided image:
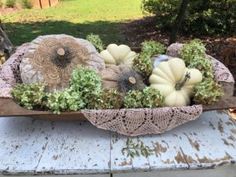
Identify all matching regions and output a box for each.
[0,0,142,45]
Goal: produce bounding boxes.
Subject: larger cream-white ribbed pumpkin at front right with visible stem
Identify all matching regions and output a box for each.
[149,58,202,106]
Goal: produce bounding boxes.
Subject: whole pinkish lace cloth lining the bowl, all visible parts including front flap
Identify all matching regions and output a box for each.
[0,40,234,136]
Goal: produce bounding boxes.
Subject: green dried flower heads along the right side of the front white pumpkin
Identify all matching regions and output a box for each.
[181,40,223,104]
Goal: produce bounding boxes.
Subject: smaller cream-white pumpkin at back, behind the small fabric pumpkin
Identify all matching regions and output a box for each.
[100,44,136,67]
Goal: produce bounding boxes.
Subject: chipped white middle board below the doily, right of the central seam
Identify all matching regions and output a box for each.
[111,130,188,172]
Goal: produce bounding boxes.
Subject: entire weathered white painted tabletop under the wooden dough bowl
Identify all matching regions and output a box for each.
[0,112,236,177]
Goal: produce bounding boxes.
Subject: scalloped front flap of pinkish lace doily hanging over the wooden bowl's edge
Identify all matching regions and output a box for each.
[82,105,202,136]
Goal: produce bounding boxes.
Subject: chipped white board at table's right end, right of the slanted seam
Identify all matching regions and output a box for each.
[171,111,236,168]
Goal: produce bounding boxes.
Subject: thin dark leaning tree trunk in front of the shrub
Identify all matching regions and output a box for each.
[169,0,190,44]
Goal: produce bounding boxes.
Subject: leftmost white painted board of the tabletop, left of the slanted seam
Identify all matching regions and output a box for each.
[0,118,53,174]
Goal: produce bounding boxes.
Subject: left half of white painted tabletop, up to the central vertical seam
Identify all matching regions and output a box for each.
[0,118,110,175]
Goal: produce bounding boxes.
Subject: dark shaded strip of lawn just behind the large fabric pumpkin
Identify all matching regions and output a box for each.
[4,21,125,46]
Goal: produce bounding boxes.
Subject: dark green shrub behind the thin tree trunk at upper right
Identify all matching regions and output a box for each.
[142,0,236,35]
